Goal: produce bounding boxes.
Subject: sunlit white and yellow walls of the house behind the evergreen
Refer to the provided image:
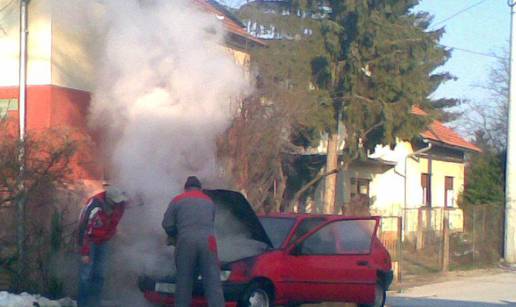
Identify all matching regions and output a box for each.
[315,142,464,215]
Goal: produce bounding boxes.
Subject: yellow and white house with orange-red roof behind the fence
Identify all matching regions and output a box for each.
[308,107,480,235]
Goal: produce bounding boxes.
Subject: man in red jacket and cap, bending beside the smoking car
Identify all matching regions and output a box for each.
[77,186,127,307]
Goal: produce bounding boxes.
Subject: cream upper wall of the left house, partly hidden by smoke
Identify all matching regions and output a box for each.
[0,0,250,92]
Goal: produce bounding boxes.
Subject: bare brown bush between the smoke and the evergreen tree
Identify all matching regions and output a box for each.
[219,90,304,211]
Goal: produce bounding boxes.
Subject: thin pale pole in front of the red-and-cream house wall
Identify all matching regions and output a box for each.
[16,0,29,284]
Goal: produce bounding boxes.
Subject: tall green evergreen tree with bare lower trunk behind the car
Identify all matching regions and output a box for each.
[230,0,457,212]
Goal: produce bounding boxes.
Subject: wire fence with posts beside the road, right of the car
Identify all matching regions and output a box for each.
[388,205,504,275]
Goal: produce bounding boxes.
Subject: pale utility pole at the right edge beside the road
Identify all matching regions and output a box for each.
[504,0,516,264]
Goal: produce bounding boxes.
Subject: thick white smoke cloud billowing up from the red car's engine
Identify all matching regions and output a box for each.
[66,0,249,305]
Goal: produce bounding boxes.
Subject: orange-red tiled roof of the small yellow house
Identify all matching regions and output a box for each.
[412,106,482,152]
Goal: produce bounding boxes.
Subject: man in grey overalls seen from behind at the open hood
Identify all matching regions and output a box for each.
[162,176,225,307]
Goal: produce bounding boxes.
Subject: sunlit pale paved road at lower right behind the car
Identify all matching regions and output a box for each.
[387,272,516,307]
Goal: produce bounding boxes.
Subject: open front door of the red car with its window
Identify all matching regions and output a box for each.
[283,217,379,303]
